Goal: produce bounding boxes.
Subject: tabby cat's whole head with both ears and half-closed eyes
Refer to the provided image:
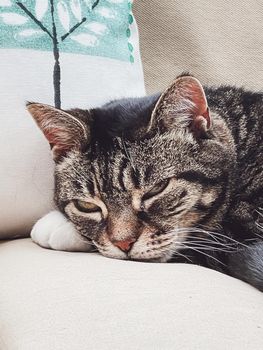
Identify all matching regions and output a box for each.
[28,76,234,261]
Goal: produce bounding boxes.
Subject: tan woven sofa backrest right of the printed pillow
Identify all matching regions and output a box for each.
[134,0,263,93]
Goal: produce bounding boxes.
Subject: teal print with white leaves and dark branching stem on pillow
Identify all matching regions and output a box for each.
[0,0,134,108]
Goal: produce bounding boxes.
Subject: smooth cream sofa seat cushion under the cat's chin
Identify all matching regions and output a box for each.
[0,239,263,350]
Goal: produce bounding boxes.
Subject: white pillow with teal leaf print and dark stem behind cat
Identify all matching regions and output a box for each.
[0,0,145,238]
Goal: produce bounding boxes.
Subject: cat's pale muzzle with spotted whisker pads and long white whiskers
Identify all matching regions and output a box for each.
[94,227,238,263]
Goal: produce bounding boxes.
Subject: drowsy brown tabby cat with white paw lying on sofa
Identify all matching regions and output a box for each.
[27,74,263,291]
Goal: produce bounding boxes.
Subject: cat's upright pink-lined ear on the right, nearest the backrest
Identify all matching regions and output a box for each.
[148,76,211,136]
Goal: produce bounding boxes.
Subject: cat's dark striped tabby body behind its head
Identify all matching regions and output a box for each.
[206,86,263,291]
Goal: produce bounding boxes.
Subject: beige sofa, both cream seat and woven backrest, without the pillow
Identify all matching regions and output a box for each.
[0,0,263,350]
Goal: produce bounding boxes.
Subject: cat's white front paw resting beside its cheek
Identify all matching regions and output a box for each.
[31,210,94,252]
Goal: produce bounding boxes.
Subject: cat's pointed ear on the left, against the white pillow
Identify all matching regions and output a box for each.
[27,102,90,160]
